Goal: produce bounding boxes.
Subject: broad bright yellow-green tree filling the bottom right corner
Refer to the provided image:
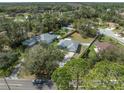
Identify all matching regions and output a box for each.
[82,61,124,89]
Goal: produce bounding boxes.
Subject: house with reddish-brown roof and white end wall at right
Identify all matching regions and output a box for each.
[94,42,114,53]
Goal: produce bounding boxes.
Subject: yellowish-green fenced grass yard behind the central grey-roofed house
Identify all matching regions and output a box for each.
[70,32,93,43]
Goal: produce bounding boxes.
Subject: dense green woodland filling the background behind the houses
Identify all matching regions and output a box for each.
[0,3,124,49]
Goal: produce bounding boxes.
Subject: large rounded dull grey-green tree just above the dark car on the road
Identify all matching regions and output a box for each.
[26,44,64,79]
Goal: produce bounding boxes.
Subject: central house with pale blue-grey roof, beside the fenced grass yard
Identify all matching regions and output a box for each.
[58,38,79,53]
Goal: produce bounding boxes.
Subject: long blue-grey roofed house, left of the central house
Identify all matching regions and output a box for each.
[22,33,57,47]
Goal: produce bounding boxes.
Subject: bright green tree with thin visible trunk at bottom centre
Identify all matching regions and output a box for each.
[65,58,88,89]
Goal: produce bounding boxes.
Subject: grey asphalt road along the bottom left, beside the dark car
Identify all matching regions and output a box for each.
[0,79,56,90]
